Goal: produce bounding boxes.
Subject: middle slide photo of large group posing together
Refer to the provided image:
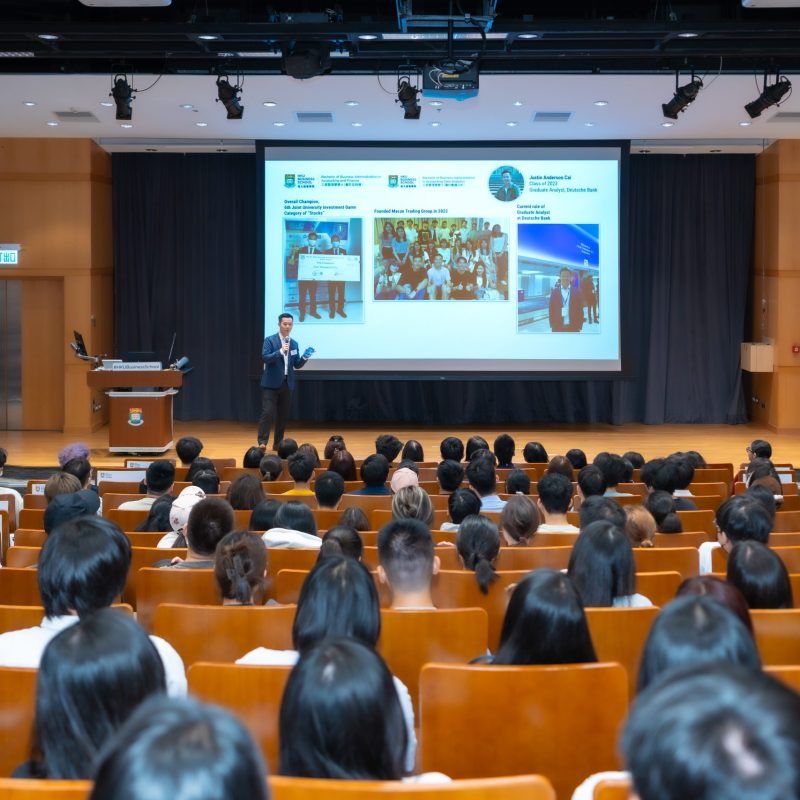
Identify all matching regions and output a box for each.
[373,217,509,302]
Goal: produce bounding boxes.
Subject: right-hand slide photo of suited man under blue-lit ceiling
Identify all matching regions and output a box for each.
[517,223,600,334]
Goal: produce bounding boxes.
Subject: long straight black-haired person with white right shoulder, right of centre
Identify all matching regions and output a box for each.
[567,520,652,608]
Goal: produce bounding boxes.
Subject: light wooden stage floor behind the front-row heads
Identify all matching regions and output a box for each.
[0,421,800,467]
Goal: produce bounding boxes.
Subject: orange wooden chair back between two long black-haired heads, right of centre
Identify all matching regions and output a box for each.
[586,606,661,700]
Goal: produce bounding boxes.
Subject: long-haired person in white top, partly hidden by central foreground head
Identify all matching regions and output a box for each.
[236,556,417,771]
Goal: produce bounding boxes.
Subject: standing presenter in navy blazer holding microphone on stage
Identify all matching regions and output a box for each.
[258,313,314,449]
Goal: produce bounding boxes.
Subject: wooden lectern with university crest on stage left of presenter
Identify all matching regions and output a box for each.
[86,369,183,453]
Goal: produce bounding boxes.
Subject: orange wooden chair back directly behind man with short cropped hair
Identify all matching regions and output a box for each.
[378,608,489,719]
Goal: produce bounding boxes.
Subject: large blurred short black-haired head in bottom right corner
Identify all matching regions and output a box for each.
[621,664,800,800]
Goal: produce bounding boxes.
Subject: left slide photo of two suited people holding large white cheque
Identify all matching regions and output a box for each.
[283,218,364,324]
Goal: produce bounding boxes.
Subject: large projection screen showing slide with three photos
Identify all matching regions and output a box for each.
[264,143,622,375]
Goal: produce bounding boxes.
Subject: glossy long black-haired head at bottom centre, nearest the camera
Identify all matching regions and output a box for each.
[278,637,424,781]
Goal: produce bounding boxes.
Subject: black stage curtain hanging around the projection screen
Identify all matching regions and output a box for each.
[113,154,755,425]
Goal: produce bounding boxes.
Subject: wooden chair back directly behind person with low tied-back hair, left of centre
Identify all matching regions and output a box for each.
[153,603,295,667]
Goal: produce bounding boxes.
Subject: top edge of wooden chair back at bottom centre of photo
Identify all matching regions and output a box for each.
[269,775,556,800]
